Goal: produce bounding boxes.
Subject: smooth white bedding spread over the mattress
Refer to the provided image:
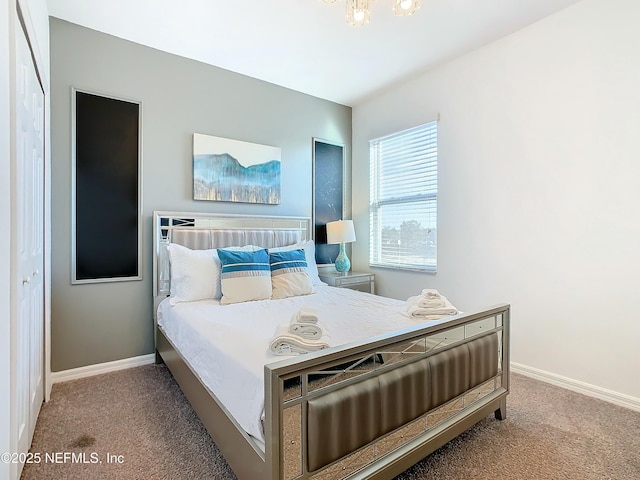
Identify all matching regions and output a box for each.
[158,286,432,441]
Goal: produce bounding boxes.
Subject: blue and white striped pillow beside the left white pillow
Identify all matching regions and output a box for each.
[218,249,271,305]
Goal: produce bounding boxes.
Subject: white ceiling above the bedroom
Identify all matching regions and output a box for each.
[48,0,579,106]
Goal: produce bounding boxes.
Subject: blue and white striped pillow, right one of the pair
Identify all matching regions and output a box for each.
[269,249,313,298]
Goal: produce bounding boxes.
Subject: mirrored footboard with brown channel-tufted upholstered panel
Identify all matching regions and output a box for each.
[265,305,509,480]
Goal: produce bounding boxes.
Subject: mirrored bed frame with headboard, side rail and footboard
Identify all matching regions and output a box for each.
[153,212,510,480]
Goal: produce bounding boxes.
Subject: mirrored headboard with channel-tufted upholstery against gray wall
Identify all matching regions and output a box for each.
[153,212,311,302]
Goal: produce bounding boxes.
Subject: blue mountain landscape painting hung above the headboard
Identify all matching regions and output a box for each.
[193,133,280,205]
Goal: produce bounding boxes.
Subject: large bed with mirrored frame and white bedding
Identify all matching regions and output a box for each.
[153,212,509,480]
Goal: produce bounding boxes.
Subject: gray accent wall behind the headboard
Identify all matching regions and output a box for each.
[50,18,351,372]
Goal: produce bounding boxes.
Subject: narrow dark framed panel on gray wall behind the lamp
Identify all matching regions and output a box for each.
[313,138,344,264]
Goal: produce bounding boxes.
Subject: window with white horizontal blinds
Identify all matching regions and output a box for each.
[369,121,438,272]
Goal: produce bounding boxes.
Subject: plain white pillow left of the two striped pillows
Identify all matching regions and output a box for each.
[169,243,221,305]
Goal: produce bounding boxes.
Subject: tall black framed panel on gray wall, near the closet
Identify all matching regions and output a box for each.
[71,89,142,283]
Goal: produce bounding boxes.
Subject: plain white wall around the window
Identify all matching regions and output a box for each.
[353,0,640,405]
